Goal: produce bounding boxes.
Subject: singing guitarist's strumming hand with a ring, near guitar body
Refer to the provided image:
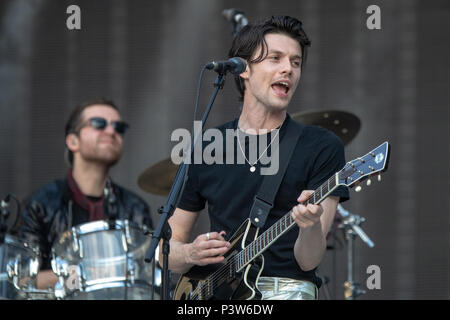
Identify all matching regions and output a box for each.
[186,231,231,266]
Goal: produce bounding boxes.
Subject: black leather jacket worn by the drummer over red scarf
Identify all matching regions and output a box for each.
[18,180,153,270]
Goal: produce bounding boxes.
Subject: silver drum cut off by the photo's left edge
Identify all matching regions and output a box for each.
[0,235,39,299]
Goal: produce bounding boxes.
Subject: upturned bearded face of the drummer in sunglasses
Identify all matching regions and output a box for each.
[68,105,123,166]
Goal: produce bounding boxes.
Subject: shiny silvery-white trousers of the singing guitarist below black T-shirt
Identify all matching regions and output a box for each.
[257,277,318,300]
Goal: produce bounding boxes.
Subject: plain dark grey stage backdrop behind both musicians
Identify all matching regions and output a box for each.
[0,0,450,299]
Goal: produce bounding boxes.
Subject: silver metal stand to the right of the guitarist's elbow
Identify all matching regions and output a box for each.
[337,204,374,300]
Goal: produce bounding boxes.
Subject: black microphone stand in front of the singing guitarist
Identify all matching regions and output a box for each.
[145,72,226,300]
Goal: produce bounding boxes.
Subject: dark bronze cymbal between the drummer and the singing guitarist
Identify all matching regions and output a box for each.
[138,158,178,196]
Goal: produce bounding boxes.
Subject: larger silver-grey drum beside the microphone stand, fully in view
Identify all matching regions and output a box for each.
[52,220,158,300]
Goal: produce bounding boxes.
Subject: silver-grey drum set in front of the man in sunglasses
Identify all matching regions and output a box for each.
[0,195,161,300]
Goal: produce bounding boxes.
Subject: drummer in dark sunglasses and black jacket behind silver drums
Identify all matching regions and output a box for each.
[19,99,152,289]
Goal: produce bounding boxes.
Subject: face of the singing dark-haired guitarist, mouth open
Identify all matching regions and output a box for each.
[241,33,302,111]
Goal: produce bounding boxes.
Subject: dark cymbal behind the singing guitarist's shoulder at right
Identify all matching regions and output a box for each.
[291,110,361,145]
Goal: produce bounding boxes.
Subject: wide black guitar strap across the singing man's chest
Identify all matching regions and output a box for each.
[250,119,303,228]
